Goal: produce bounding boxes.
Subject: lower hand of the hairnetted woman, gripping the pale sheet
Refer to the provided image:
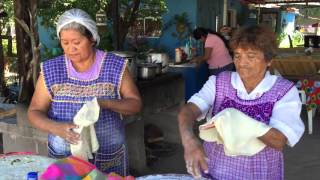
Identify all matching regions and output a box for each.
[52,122,80,145]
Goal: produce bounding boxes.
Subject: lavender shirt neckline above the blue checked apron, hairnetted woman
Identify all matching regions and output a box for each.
[67,49,105,80]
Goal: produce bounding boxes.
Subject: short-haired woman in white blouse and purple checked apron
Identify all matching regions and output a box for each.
[178,26,304,180]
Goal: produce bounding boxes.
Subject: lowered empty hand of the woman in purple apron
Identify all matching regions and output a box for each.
[184,139,209,178]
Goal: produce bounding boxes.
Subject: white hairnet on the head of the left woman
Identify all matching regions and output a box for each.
[57,9,100,45]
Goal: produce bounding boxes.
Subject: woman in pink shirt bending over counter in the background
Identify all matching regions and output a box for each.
[191,27,234,75]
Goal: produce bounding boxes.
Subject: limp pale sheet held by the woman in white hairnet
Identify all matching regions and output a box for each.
[70,98,100,161]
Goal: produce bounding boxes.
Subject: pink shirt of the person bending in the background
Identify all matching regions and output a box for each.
[204,33,232,69]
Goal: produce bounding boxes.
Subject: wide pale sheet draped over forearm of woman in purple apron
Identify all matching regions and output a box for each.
[199,108,271,156]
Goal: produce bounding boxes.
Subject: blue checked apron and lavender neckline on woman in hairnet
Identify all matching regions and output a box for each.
[41,50,128,176]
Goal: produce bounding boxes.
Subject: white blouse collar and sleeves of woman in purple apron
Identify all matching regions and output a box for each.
[188,72,304,147]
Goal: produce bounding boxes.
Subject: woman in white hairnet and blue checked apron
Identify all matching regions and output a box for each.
[28,9,141,176]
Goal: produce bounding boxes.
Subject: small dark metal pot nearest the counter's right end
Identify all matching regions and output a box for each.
[138,63,158,80]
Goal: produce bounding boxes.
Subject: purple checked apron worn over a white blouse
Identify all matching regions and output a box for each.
[203,72,294,180]
